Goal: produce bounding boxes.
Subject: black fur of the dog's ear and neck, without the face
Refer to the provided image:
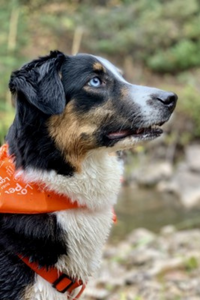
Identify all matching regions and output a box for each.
[6,51,74,176]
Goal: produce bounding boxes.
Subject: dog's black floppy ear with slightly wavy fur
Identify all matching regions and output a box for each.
[9,51,66,115]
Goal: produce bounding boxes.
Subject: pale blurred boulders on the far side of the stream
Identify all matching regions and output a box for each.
[126,144,200,209]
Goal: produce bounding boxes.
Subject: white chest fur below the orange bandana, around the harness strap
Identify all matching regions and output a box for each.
[32,209,112,300]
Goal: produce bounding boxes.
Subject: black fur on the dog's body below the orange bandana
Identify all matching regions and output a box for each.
[0,214,67,300]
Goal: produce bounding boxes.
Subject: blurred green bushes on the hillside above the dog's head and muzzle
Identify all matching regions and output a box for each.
[15,0,200,73]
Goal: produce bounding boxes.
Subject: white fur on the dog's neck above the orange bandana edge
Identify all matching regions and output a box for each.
[21,149,123,210]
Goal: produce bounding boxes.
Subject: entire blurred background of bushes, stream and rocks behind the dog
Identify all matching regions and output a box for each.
[0,0,200,300]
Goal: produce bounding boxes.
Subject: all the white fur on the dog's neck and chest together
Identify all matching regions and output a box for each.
[25,150,123,300]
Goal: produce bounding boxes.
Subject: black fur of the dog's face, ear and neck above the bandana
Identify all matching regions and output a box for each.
[7,51,126,176]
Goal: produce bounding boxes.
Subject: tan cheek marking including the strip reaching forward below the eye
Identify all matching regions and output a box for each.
[48,100,124,172]
